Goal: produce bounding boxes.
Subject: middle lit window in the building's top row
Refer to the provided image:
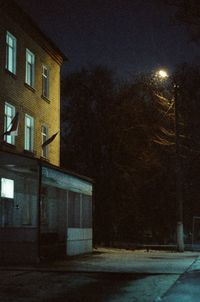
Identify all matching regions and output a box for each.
[25,49,35,87]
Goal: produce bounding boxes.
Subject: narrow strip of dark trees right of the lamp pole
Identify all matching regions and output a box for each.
[176,65,200,234]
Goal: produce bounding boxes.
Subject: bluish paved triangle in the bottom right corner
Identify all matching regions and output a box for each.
[160,257,200,302]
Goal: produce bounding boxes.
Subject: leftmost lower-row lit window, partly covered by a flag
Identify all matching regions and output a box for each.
[4,103,15,145]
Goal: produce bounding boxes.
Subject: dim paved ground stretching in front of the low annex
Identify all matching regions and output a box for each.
[0,249,199,302]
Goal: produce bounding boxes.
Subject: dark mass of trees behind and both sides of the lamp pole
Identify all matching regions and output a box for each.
[62,66,200,243]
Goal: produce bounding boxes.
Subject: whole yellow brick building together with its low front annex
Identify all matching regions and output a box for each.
[0,0,93,263]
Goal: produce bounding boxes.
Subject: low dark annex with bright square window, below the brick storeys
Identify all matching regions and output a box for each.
[0,151,93,263]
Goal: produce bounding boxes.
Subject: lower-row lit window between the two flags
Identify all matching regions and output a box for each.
[24,114,34,151]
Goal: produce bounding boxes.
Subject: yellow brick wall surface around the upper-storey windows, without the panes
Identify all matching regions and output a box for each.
[0,14,60,166]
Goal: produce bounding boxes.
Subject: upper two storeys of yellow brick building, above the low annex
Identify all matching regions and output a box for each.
[0,0,62,166]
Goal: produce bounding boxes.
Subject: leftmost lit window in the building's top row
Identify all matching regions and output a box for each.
[6,32,17,74]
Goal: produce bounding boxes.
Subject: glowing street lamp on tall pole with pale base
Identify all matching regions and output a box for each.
[156,70,184,252]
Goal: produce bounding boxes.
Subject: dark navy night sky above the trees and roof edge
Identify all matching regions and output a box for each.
[16,0,200,77]
